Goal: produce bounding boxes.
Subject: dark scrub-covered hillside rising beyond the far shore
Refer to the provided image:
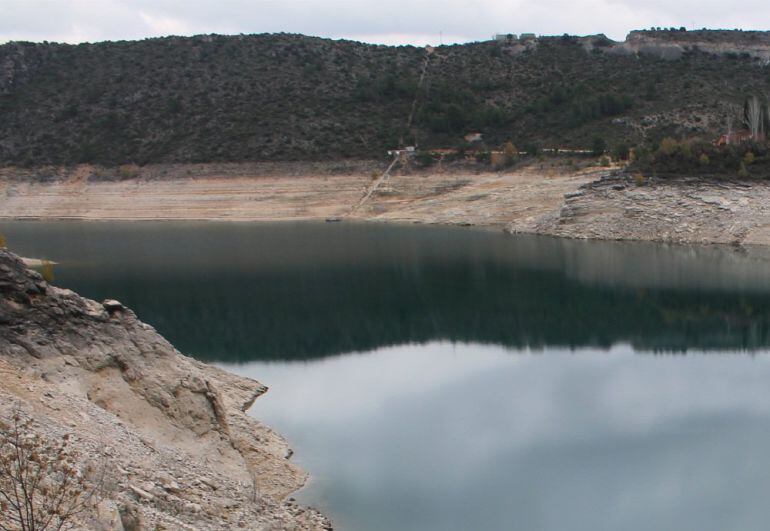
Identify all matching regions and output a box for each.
[0,31,770,166]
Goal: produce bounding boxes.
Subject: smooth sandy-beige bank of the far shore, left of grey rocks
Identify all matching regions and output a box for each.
[0,164,603,227]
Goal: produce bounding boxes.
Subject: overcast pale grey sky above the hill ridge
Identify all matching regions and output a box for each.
[0,0,770,45]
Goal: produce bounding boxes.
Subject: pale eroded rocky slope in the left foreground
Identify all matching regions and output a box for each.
[0,249,330,530]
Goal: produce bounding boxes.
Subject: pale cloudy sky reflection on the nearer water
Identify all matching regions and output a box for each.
[228,342,770,530]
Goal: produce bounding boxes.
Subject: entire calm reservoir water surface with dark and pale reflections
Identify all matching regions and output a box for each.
[0,218,770,531]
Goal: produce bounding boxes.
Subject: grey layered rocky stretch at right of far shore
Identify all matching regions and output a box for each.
[507,171,770,245]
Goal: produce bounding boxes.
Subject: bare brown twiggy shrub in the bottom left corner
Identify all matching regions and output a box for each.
[0,411,97,531]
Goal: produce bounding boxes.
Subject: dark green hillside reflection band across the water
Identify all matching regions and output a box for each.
[60,261,770,362]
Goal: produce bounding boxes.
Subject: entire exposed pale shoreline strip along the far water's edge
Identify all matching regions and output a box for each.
[0,158,770,245]
